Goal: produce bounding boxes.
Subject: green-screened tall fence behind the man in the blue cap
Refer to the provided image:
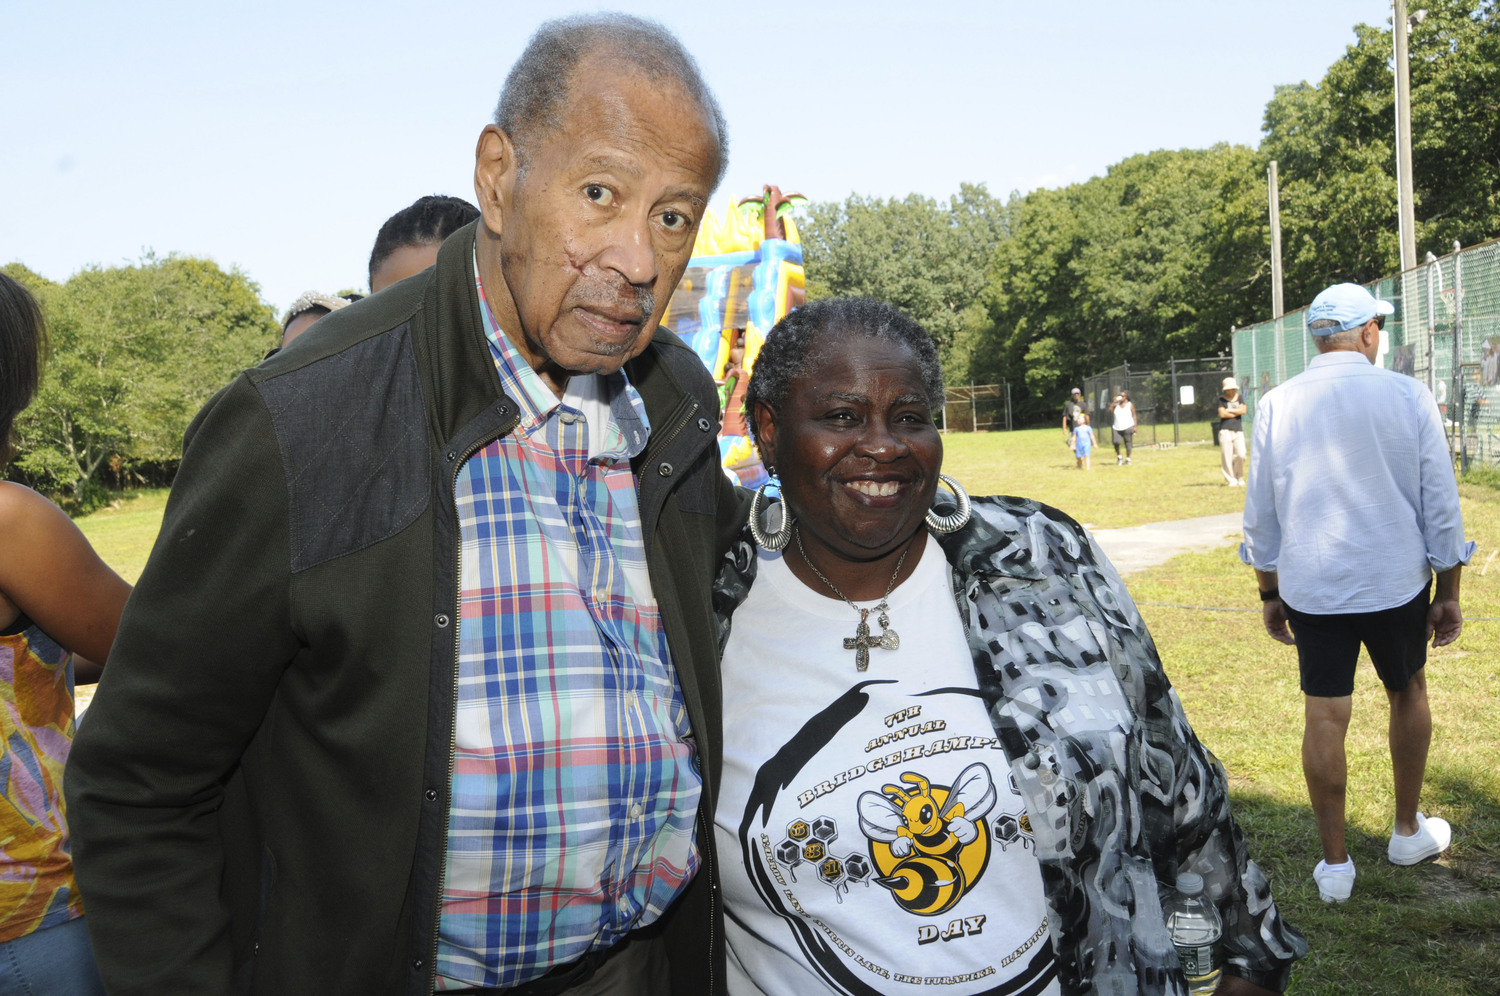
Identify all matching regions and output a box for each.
[1235,240,1500,470]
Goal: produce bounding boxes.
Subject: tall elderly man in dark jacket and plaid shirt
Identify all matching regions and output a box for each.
[68,15,735,996]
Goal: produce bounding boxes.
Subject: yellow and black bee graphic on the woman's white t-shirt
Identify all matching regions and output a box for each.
[858,764,996,917]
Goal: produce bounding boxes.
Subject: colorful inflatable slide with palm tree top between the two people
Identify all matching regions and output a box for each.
[662,186,807,488]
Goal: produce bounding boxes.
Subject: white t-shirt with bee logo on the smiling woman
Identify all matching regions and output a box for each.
[714,537,1059,996]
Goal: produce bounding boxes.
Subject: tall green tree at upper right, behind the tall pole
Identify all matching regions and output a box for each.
[1260,0,1500,306]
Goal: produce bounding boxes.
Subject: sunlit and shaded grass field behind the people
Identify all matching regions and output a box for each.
[80,425,1500,996]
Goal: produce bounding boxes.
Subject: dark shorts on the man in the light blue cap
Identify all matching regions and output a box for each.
[1283,582,1433,699]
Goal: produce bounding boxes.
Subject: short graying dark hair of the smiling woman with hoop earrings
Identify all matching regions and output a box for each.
[746,297,944,437]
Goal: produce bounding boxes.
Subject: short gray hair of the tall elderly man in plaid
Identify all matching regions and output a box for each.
[495,14,729,189]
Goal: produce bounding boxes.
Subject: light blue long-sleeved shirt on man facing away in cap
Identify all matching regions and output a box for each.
[1239,350,1475,615]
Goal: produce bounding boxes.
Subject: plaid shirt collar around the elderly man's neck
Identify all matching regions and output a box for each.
[474,248,651,462]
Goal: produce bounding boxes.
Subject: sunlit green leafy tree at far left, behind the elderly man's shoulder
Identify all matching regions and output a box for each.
[8,255,278,498]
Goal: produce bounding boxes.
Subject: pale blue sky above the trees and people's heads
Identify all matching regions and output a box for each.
[0,0,1391,309]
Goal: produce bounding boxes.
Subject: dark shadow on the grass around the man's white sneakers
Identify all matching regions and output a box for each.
[1230,792,1500,996]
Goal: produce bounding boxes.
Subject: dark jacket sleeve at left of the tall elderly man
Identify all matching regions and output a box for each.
[66,375,297,996]
